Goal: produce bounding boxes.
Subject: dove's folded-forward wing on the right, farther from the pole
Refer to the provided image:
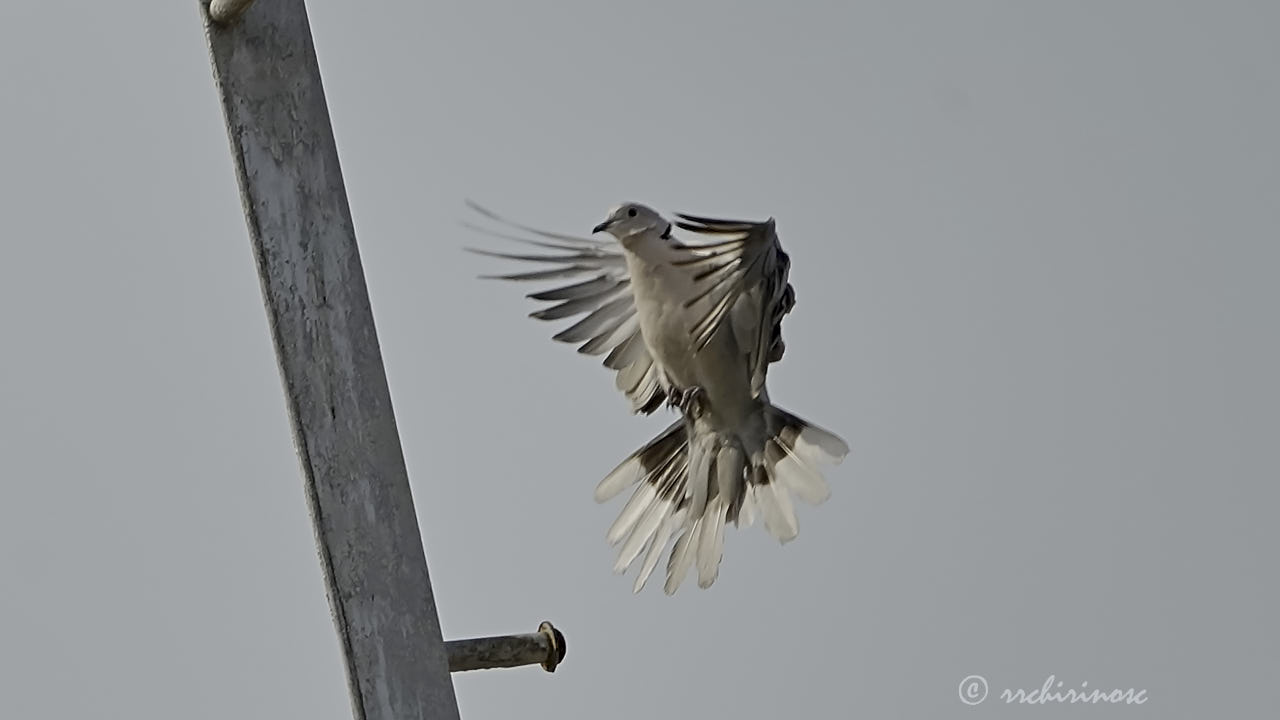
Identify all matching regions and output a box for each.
[676,214,795,395]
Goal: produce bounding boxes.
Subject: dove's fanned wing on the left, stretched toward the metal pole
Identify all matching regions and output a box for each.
[467,201,667,415]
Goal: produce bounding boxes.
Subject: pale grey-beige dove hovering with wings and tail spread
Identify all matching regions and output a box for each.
[471,202,849,594]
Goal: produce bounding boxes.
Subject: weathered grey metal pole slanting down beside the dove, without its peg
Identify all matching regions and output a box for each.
[200,0,458,720]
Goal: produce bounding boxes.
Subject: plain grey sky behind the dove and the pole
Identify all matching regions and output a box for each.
[0,0,1280,720]
